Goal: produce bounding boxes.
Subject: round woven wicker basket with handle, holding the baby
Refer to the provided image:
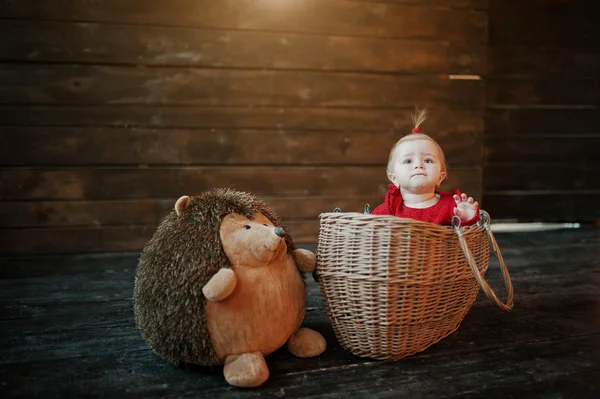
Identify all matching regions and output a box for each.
[315,212,513,360]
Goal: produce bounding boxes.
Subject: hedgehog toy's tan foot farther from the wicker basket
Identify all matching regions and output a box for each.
[223,352,269,388]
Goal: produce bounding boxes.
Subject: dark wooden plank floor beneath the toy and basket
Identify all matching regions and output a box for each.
[0,227,600,398]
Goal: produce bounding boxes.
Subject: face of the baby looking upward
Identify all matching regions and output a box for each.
[388,139,446,194]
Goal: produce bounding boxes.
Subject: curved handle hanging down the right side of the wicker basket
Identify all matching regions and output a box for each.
[452,211,514,312]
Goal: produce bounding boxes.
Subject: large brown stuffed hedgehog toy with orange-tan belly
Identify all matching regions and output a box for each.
[133,189,326,387]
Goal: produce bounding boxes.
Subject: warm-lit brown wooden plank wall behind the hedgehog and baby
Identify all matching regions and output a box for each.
[0,0,487,255]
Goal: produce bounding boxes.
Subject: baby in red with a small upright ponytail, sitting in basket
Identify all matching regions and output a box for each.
[371,110,479,226]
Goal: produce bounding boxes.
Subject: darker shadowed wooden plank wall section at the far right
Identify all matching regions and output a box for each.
[483,0,600,222]
